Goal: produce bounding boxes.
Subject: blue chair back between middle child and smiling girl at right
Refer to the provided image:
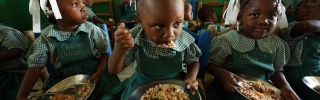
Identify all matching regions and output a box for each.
[197,29,212,79]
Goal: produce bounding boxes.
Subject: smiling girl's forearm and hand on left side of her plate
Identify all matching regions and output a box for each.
[208,63,243,92]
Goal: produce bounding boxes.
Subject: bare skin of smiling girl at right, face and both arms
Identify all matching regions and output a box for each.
[208,0,299,100]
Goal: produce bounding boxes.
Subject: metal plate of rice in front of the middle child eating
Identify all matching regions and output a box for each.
[129,79,202,100]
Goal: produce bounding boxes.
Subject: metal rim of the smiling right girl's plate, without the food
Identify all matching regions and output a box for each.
[234,74,281,99]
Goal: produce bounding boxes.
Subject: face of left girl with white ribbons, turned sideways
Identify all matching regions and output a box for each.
[57,0,89,25]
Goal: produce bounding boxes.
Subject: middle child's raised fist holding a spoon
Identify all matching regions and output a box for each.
[114,23,134,50]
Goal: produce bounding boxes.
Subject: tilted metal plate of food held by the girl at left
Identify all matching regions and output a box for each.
[31,74,95,100]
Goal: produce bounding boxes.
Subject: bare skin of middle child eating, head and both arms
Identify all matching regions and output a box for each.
[108,0,199,93]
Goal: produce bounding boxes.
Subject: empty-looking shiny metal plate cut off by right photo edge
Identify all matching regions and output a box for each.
[302,76,320,94]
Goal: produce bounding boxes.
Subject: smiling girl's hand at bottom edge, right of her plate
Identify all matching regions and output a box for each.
[281,86,300,100]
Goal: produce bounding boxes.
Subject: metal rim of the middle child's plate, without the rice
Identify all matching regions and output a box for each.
[129,79,202,100]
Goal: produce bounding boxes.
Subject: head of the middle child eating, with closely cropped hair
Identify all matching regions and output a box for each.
[137,0,184,44]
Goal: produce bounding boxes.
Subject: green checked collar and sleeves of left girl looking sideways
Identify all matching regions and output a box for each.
[27,22,109,69]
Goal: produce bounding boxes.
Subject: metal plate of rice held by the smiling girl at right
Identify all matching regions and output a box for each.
[234,74,281,100]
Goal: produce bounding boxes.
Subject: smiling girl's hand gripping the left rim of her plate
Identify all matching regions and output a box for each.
[220,70,244,92]
